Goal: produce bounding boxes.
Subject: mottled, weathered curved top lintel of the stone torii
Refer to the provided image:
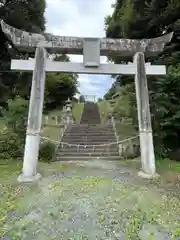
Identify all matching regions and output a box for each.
[1,21,173,56]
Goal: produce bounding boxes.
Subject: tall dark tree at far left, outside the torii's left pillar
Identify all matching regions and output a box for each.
[0,0,46,107]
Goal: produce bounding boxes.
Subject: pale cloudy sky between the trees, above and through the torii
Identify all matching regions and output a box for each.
[46,0,114,97]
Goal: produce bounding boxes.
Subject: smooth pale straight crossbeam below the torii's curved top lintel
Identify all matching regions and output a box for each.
[11,59,166,75]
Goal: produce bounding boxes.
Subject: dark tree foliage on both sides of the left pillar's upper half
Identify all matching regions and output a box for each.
[0,0,77,110]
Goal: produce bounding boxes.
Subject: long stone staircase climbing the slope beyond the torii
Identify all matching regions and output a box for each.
[56,103,119,160]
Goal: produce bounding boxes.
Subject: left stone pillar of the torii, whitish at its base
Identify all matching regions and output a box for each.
[18,46,47,182]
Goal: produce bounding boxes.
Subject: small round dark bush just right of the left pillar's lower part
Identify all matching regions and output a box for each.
[39,141,56,162]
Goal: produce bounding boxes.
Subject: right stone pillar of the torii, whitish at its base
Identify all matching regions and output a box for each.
[134,52,158,178]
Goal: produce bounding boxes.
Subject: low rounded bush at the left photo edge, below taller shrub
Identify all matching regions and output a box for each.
[0,130,24,161]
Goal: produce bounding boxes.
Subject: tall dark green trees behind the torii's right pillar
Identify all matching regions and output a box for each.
[105,0,180,158]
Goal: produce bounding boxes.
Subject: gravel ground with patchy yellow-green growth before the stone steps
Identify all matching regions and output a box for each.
[1,161,180,240]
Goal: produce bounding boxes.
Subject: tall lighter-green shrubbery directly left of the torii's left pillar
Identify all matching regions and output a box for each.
[0,97,28,161]
